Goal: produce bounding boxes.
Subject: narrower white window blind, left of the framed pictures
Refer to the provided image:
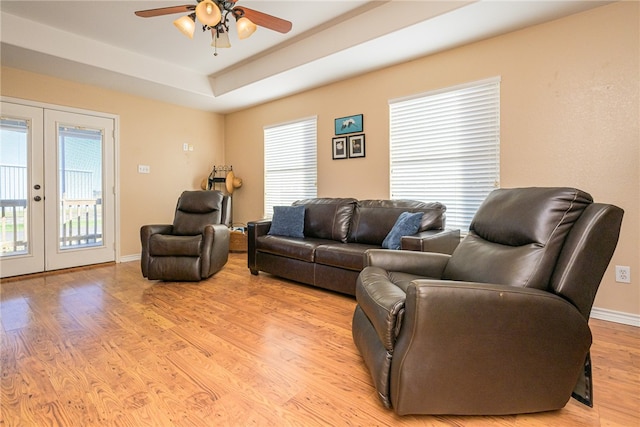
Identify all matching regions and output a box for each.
[264,117,318,218]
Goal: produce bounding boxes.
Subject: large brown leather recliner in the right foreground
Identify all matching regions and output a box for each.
[352,188,623,415]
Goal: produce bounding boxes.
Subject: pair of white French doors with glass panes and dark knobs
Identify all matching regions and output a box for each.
[0,102,115,277]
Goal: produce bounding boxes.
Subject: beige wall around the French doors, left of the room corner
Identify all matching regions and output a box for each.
[0,67,224,256]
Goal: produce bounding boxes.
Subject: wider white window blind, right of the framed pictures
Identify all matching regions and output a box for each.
[389,77,500,233]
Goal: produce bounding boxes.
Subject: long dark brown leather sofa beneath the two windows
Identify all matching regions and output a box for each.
[247,198,460,295]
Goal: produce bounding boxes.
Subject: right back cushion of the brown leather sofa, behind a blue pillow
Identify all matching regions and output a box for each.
[348,200,446,245]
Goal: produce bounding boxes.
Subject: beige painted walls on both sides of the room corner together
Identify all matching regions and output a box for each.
[0,2,640,315]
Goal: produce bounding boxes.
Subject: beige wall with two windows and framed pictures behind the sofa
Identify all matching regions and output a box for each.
[225,2,640,314]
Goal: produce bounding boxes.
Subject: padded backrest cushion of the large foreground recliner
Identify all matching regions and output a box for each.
[443,187,593,290]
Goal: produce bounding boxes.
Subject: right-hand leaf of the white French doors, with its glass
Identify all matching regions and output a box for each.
[44,110,115,270]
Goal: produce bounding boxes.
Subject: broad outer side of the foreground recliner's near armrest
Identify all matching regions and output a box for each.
[390,280,591,415]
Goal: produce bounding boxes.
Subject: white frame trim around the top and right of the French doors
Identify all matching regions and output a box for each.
[0,96,121,272]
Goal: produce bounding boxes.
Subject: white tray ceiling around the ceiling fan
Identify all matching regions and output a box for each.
[0,0,610,113]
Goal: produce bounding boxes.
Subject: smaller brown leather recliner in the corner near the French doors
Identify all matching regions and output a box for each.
[140,191,230,281]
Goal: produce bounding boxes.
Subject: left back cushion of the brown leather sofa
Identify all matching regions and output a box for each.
[293,198,358,243]
